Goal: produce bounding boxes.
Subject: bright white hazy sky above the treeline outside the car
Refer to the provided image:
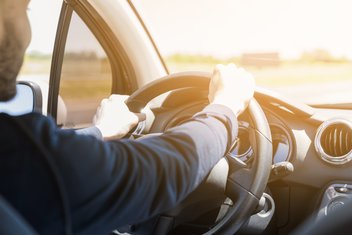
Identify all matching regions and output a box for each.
[28,0,352,58]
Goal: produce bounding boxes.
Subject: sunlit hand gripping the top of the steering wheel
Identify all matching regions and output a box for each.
[208,64,255,116]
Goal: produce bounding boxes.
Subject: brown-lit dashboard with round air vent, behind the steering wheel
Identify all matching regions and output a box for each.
[148,87,352,234]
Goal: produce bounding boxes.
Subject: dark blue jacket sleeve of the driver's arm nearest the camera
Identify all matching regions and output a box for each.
[29,105,237,234]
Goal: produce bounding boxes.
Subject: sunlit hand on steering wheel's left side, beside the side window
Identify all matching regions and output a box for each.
[93,95,138,140]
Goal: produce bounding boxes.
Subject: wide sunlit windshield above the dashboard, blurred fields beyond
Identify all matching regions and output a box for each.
[133,0,352,104]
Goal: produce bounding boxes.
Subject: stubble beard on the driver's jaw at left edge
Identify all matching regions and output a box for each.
[0,23,24,101]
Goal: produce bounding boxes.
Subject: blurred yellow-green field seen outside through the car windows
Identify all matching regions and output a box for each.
[22,56,352,99]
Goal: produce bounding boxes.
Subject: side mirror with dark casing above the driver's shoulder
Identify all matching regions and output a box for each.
[0,81,42,115]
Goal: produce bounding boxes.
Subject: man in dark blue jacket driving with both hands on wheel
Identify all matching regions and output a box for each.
[0,0,254,234]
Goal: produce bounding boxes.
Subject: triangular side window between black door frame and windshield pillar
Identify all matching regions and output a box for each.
[58,12,112,128]
